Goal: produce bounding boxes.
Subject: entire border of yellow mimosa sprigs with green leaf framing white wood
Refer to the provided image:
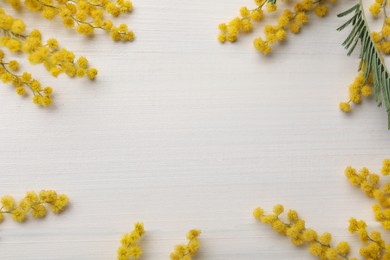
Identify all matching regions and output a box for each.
[0,0,390,260]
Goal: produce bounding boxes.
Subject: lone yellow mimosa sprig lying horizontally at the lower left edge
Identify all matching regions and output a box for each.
[0,190,68,222]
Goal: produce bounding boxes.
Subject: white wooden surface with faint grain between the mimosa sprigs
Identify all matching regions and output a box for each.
[0,0,389,260]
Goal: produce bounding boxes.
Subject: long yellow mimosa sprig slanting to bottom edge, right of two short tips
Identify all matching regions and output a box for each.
[253,204,354,260]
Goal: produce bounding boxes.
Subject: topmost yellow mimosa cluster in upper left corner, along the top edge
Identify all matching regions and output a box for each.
[7,0,135,41]
